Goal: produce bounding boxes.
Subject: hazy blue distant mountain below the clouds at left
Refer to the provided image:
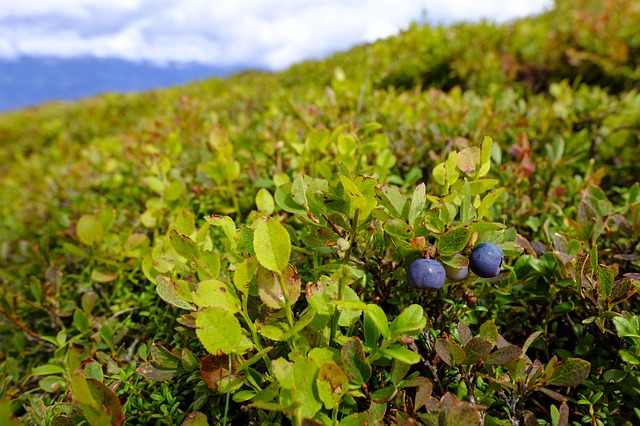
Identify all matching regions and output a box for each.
[0,57,243,112]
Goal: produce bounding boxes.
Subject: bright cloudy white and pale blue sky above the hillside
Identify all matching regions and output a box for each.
[0,0,553,70]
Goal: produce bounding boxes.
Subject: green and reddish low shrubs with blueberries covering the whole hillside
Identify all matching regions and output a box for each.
[0,0,640,426]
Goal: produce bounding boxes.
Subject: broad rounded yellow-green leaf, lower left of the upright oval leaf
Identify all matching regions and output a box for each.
[195,308,242,355]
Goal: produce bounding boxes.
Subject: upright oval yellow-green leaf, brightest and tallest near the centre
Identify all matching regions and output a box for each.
[253,218,291,272]
